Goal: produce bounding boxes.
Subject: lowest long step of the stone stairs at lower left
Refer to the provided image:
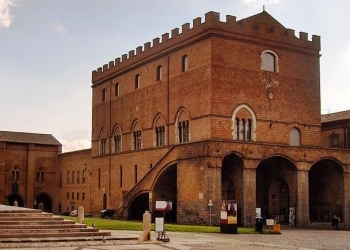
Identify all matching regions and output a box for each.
[0,231,111,239]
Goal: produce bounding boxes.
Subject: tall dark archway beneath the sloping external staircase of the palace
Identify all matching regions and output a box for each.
[152,164,177,222]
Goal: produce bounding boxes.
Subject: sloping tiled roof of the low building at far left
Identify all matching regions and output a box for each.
[0,131,62,146]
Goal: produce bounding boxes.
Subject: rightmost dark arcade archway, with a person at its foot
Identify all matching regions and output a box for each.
[309,159,344,222]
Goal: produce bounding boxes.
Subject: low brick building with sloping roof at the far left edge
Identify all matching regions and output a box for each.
[0,131,62,212]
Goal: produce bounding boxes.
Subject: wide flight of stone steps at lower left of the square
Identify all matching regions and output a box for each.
[0,205,111,242]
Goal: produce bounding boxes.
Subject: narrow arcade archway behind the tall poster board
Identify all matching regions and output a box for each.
[221,153,243,226]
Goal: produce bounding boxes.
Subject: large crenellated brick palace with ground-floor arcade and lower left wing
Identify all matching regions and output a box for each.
[0,11,350,229]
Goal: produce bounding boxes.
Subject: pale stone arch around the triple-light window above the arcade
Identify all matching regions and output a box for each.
[231,104,256,141]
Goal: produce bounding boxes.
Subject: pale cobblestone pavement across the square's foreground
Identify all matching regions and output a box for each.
[0,229,350,250]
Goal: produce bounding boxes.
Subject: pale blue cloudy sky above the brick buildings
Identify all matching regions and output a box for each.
[0,0,350,152]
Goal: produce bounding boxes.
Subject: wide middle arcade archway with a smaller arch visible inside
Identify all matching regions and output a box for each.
[256,156,297,224]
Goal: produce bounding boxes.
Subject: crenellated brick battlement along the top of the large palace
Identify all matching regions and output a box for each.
[92,11,321,84]
